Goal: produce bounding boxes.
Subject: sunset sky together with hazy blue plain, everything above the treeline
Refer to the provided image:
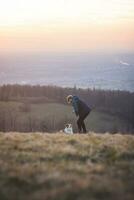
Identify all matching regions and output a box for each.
[0,0,134,91]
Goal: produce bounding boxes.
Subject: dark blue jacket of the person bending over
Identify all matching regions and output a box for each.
[72,96,91,116]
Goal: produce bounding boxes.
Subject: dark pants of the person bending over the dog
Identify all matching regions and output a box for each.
[77,112,90,133]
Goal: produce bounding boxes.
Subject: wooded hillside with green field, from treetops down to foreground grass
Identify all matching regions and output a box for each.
[0,85,134,133]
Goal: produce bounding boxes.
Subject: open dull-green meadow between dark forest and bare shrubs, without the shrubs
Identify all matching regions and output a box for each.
[0,102,127,132]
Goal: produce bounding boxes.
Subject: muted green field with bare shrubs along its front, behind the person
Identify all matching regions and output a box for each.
[0,101,126,133]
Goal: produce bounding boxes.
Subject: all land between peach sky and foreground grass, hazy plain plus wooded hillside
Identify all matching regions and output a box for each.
[0,52,134,133]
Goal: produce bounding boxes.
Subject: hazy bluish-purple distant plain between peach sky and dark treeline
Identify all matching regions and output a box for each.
[0,52,134,92]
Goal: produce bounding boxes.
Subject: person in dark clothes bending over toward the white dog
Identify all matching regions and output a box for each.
[66,95,91,133]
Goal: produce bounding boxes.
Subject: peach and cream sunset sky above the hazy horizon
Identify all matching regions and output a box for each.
[0,0,134,52]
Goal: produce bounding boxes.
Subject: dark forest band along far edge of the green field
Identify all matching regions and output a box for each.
[0,84,134,132]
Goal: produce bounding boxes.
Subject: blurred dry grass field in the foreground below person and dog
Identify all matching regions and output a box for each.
[0,133,134,200]
